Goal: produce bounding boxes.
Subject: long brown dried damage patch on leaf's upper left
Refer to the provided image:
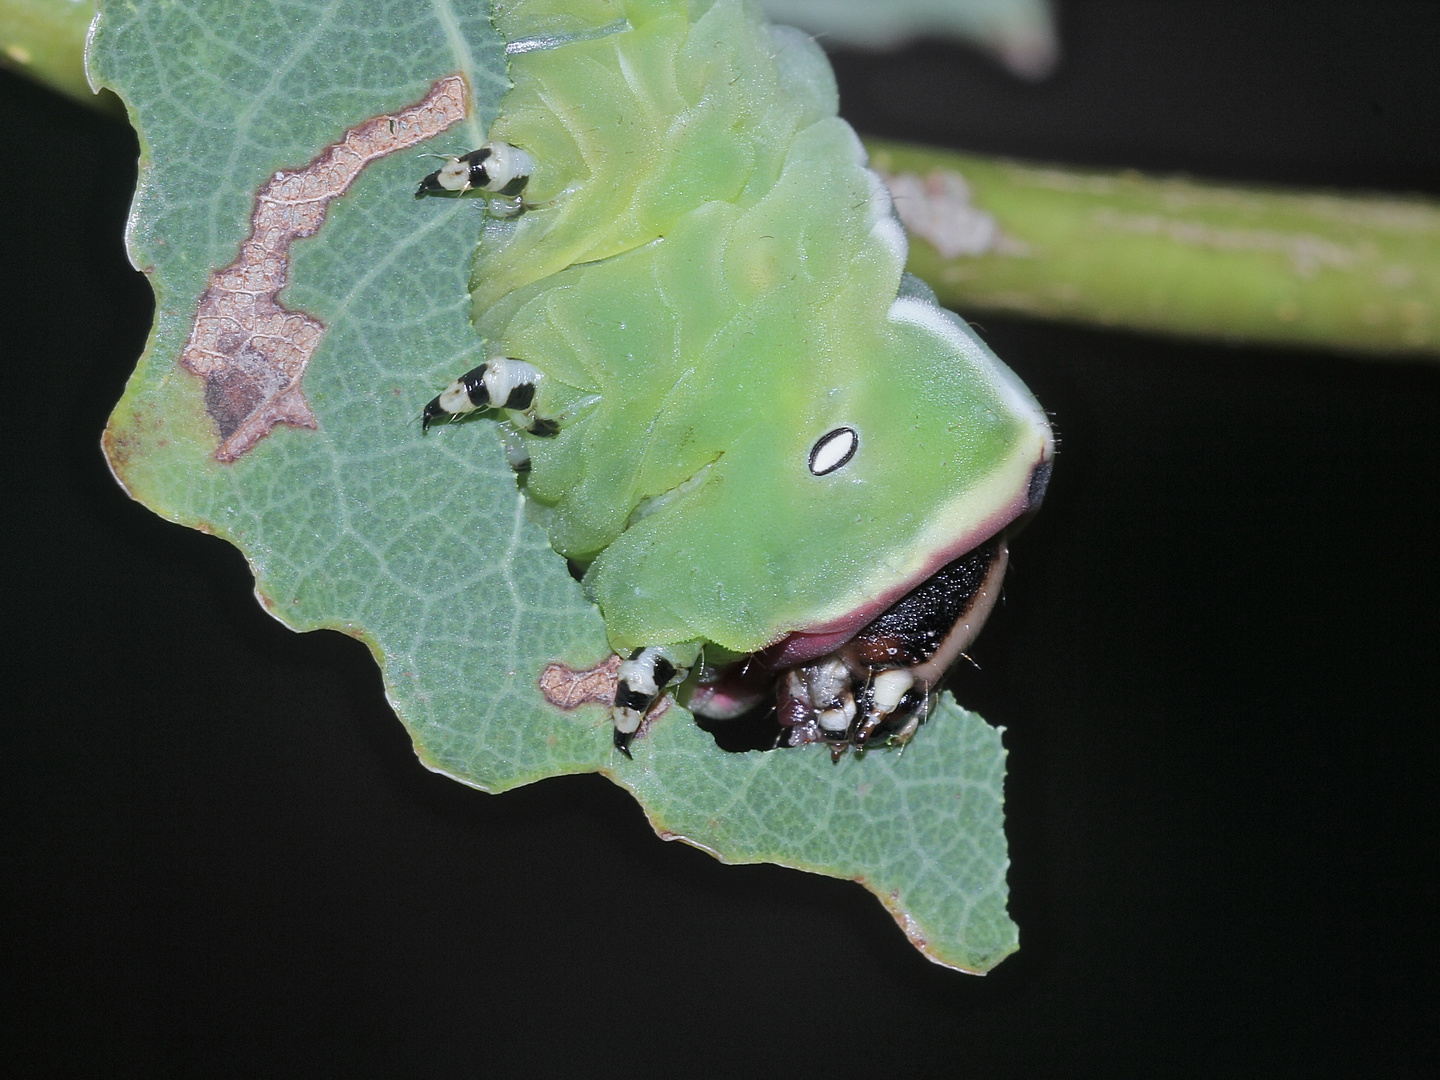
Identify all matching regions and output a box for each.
[180,75,467,462]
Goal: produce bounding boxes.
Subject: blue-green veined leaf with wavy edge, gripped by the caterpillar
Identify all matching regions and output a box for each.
[89,0,1017,972]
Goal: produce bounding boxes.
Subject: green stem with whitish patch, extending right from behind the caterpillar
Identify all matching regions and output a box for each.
[868,140,1440,356]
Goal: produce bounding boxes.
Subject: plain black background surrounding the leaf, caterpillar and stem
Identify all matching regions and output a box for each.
[0,1,1440,1077]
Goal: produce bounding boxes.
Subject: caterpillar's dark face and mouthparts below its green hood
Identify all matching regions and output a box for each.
[688,536,1008,757]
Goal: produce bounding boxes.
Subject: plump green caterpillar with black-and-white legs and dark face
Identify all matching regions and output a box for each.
[418,0,1054,753]
